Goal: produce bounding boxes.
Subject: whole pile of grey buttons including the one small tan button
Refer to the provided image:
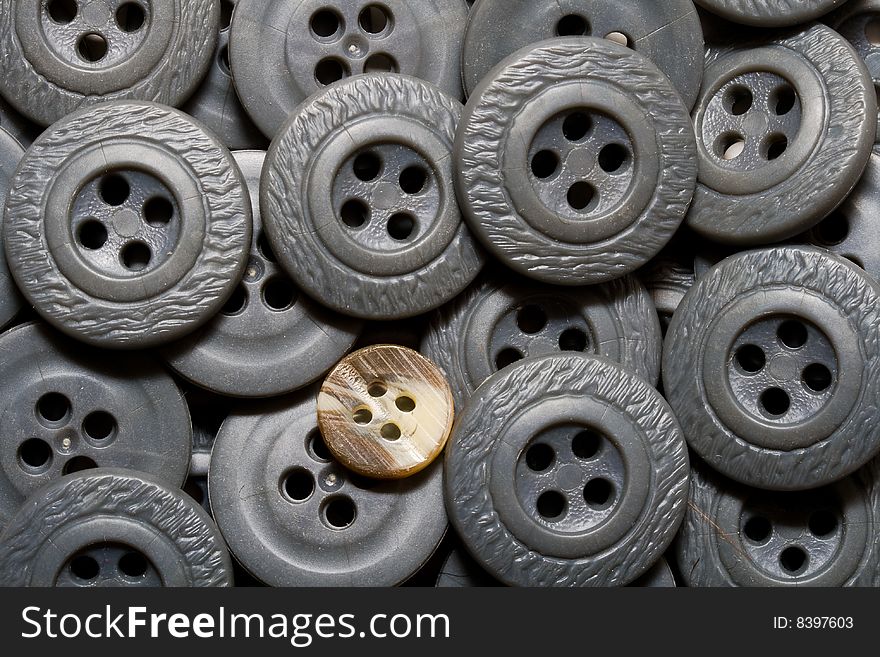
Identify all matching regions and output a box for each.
[0,0,880,586]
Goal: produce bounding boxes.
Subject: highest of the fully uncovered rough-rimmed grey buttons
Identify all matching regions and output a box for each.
[455,38,697,286]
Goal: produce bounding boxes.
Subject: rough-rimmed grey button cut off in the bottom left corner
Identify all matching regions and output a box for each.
[0,468,232,587]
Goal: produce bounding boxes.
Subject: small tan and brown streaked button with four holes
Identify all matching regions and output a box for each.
[318,345,454,479]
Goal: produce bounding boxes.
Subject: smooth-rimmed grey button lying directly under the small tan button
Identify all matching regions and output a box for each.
[208,390,447,586]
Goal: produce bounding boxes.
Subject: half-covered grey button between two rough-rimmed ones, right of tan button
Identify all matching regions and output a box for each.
[420,273,662,408]
